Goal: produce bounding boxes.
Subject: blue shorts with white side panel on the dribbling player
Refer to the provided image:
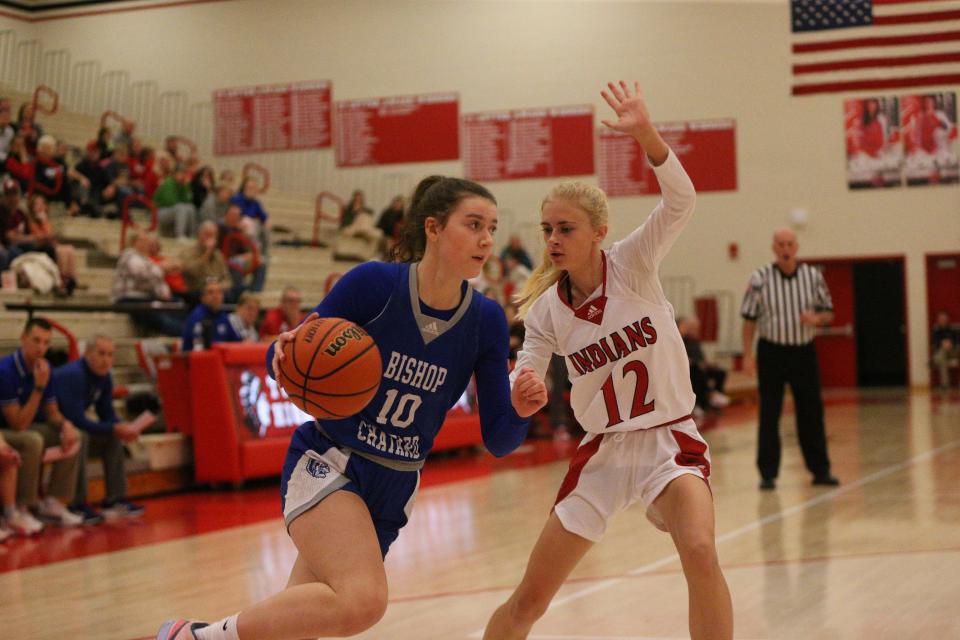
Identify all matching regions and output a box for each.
[280,422,420,556]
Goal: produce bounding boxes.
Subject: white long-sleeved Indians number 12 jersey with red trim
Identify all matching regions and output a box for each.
[513,151,696,433]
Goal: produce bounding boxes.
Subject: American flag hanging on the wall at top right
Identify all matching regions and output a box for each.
[790,0,960,95]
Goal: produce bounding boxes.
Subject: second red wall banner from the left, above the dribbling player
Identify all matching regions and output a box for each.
[335,93,460,167]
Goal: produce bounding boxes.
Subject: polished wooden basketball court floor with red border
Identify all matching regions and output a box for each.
[0,391,960,640]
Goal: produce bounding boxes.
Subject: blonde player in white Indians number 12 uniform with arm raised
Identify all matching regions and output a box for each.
[484,81,733,640]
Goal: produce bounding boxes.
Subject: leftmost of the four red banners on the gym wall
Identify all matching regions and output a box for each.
[213,80,331,156]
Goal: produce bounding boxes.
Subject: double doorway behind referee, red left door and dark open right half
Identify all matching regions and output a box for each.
[812,257,907,387]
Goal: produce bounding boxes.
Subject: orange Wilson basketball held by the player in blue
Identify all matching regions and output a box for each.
[279,318,381,420]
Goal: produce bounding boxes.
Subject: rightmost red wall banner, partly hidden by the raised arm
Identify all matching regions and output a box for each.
[599,119,737,196]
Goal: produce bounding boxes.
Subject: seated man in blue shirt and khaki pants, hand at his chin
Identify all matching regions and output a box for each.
[0,318,83,527]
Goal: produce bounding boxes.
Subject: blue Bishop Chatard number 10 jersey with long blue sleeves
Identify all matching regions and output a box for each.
[267,262,529,462]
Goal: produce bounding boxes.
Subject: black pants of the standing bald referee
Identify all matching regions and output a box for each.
[757,340,830,479]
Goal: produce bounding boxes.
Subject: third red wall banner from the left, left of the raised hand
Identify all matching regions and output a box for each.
[463,105,594,181]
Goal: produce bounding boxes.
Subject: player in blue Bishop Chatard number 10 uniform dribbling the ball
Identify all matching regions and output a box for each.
[157,176,547,640]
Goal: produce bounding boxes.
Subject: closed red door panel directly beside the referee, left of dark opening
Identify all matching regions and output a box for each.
[815,261,857,388]
